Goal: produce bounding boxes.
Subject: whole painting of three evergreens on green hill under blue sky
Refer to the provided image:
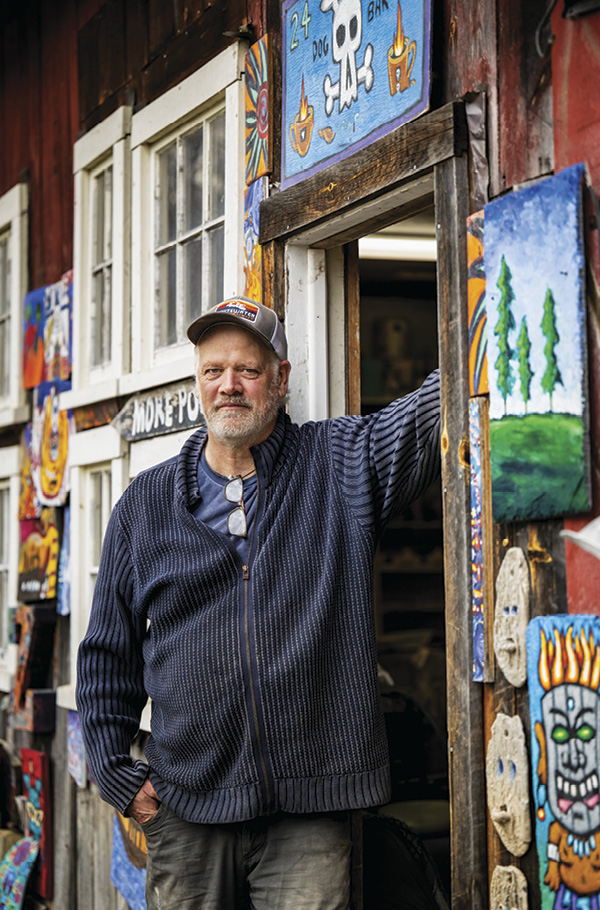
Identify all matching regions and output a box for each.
[483,164,591,521]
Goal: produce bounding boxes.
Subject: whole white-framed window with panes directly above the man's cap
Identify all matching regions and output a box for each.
[129,44,245,384]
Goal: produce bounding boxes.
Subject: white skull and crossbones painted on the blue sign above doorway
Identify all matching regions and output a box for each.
[321,0,373,117]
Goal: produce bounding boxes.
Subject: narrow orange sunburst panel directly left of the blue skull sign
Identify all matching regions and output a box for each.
[244,35,273,186]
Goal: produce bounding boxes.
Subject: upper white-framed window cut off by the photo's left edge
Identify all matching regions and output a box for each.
[0,183,28,426]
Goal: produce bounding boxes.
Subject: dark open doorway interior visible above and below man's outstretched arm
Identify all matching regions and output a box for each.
[358,206,450,894]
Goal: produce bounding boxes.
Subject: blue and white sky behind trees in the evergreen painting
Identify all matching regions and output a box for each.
[484,164,585,419]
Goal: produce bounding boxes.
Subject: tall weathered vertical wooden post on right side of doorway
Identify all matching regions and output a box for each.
[435,156,487,910]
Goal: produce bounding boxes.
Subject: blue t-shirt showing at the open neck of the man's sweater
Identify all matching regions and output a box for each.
[194,451,258,565]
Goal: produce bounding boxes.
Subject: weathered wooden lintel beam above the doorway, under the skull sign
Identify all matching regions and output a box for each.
[260,102,467,243]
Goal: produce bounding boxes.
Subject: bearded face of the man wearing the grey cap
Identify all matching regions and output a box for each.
[196,325,290,448]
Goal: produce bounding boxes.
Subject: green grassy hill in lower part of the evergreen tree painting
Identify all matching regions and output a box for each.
[490,414,590,521]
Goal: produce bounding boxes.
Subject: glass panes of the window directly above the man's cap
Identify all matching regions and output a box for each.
[154,110,225,348]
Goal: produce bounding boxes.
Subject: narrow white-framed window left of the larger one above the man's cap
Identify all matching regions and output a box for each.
[68,107,131,396]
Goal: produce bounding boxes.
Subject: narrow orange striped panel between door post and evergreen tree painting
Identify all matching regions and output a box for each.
[467,209,489,395]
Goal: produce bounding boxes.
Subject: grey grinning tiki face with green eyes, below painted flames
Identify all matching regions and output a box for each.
[542,683,600,836]
